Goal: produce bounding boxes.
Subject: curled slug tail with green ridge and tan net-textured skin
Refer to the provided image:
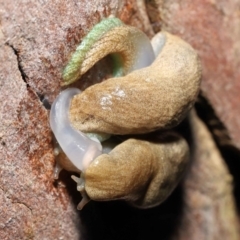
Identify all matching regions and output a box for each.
[62,17,155,85]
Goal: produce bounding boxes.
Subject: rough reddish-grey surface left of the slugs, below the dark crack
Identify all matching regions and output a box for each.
[0,45,80,239]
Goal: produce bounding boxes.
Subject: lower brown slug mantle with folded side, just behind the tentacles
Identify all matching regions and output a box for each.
[83,133,189,208]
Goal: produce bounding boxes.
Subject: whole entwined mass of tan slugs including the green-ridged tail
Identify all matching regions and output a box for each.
[50,18,201,209]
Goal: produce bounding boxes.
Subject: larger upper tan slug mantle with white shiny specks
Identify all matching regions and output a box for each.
[70,32,201,134]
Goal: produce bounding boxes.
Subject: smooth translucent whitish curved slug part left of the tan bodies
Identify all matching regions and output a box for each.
[50,88,102,171]
